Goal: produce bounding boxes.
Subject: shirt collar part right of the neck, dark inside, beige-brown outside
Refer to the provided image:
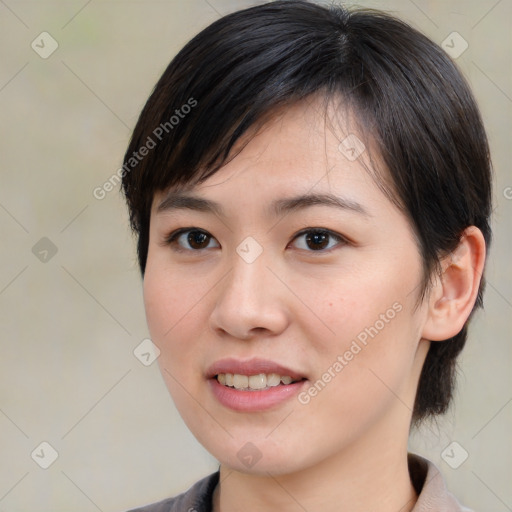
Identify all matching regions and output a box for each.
[408,453,474,512]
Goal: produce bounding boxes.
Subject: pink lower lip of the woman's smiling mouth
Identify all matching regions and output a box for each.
[209,378,307,412]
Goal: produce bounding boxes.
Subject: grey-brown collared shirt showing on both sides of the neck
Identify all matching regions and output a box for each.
[130,453,472,512]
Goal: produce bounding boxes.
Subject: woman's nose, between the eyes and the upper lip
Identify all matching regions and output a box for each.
[210,247,289,340]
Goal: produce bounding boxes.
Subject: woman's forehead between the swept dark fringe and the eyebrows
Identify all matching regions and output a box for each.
[150,97,394,216]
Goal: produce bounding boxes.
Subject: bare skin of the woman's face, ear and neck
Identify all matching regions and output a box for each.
[144,96,485,512]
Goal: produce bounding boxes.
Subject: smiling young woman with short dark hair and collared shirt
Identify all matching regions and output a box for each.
[123,1,491,512]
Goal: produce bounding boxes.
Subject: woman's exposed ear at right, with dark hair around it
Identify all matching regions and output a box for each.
[422,226,486,341]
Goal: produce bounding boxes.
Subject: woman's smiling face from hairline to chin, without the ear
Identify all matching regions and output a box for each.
[144,98,428,474]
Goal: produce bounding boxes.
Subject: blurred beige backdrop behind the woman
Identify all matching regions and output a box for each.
[0,0,512,512]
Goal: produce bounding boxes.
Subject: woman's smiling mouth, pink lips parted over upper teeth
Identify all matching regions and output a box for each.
[207,359,307,412]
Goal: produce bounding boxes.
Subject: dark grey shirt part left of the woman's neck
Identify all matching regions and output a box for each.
[128,471,219,512]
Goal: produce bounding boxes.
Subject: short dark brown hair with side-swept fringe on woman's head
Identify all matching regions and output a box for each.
[122,0,492,423]
